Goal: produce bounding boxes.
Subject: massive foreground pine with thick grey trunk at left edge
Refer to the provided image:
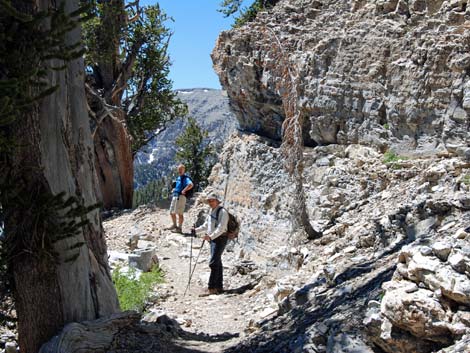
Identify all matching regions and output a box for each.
[0,0,119,353]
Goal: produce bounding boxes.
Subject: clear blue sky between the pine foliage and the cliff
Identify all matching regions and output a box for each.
[141,0,241,89]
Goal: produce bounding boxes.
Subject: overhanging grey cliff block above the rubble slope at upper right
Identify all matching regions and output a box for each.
[212,0,470,155]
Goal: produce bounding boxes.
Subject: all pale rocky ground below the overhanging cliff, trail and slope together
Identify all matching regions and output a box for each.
[34,134,470,353]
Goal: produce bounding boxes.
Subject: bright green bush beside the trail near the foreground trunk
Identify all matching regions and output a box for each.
[112,266,163,312]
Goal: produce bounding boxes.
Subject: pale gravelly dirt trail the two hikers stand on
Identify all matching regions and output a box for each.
[104,208,262,352]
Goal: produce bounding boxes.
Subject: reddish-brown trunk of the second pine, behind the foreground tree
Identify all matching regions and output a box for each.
[92,0,135,209]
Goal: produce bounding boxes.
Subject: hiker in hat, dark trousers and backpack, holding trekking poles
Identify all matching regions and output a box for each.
[195,193,229,296]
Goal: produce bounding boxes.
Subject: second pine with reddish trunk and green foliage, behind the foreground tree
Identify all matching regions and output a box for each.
[81,0,186,208]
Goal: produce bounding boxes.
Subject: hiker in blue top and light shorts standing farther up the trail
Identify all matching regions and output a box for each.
[167,164,194,233]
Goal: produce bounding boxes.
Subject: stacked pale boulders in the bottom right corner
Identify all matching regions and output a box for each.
[366,231,470,352]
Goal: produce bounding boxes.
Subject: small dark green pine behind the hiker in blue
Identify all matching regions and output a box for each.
[175,118,215,191]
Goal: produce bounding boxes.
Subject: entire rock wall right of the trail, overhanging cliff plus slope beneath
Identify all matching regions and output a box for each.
[211,0,470,353]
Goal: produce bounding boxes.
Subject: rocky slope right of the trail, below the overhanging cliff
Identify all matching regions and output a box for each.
[210,134,470,353]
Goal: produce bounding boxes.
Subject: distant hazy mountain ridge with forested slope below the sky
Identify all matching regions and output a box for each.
[134,88,239,188]
